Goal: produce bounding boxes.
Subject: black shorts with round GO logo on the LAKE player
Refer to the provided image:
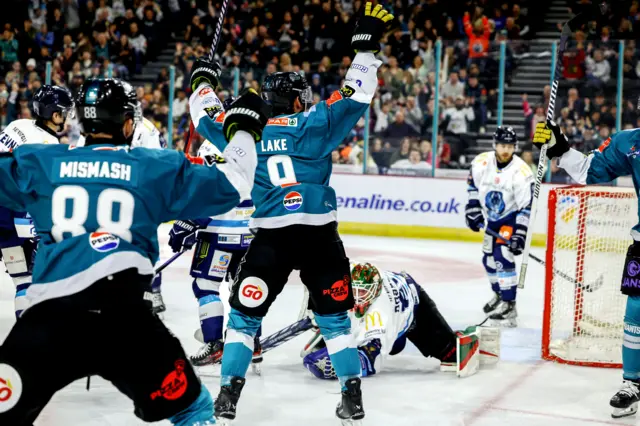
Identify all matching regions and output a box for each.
[230,222,354,317]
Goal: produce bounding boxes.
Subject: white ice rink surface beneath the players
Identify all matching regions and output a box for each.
[0,226,640,426]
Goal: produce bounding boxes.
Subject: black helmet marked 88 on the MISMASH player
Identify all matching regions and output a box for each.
[77,78,141,143]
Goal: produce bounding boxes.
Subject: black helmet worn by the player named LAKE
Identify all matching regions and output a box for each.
[262,72,313,116]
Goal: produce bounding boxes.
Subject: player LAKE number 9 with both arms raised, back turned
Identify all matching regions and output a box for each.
[189,2,392,422]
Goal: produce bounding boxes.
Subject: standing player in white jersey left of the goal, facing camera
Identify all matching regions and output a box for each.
[465,127,533,327]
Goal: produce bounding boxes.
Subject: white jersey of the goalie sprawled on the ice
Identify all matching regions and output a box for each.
[351,270,419,355]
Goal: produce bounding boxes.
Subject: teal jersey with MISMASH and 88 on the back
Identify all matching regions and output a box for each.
[0,138,256,312]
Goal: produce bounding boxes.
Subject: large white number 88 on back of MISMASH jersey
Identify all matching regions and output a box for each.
[51,185,135,242]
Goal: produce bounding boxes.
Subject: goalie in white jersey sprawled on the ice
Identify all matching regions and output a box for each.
[302,263,500,379]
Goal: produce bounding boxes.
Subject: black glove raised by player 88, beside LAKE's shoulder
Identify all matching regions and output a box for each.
[222,89,272,142]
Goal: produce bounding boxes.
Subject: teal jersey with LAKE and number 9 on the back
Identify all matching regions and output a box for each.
[189,52,381,228]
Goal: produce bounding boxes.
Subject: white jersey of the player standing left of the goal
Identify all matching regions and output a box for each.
[468,151,533,222]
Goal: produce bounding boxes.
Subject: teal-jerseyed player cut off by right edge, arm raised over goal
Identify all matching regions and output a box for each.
[533,121,640,418]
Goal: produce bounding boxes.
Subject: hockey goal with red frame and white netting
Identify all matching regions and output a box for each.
[542,187,638,367]
